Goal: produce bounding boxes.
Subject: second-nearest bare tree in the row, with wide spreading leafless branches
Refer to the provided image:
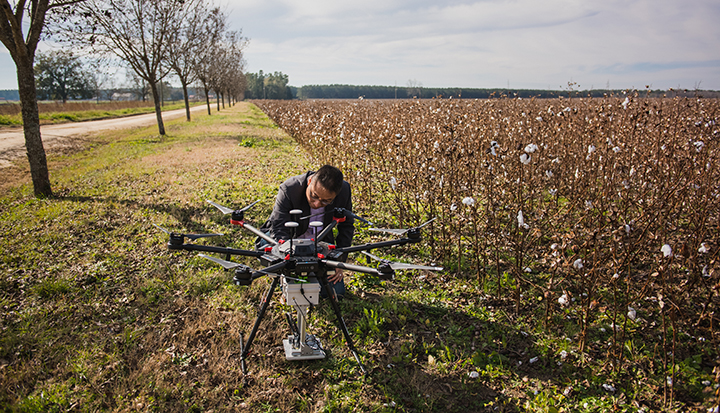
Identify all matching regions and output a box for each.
[62,0,193,135]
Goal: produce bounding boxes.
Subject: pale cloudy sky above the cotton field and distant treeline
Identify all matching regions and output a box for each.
[0,0,720,90]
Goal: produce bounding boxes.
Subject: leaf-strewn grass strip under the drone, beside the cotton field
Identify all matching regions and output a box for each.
[0,103,717,412]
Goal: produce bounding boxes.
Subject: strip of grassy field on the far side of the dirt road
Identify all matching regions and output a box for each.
[0,101,204,126]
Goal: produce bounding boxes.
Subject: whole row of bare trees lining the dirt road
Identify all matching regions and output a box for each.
[0,0,246,196]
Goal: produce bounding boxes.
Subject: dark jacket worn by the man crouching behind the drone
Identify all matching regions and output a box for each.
[260,171,355,247]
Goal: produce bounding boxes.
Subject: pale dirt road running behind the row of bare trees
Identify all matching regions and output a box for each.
[0,105,207,168]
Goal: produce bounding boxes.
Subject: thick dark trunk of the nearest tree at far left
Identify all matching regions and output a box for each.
[16,59,52,197]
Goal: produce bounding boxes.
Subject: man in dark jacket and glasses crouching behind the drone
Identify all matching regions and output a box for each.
[256,165,355,298]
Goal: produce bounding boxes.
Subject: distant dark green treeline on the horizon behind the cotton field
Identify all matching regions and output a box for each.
[290,85,720,99]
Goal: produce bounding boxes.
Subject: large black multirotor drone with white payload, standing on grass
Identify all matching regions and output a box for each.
[153,200,443,374]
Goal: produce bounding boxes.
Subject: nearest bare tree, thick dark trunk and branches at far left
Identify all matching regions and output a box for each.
[0,0,83,196]
